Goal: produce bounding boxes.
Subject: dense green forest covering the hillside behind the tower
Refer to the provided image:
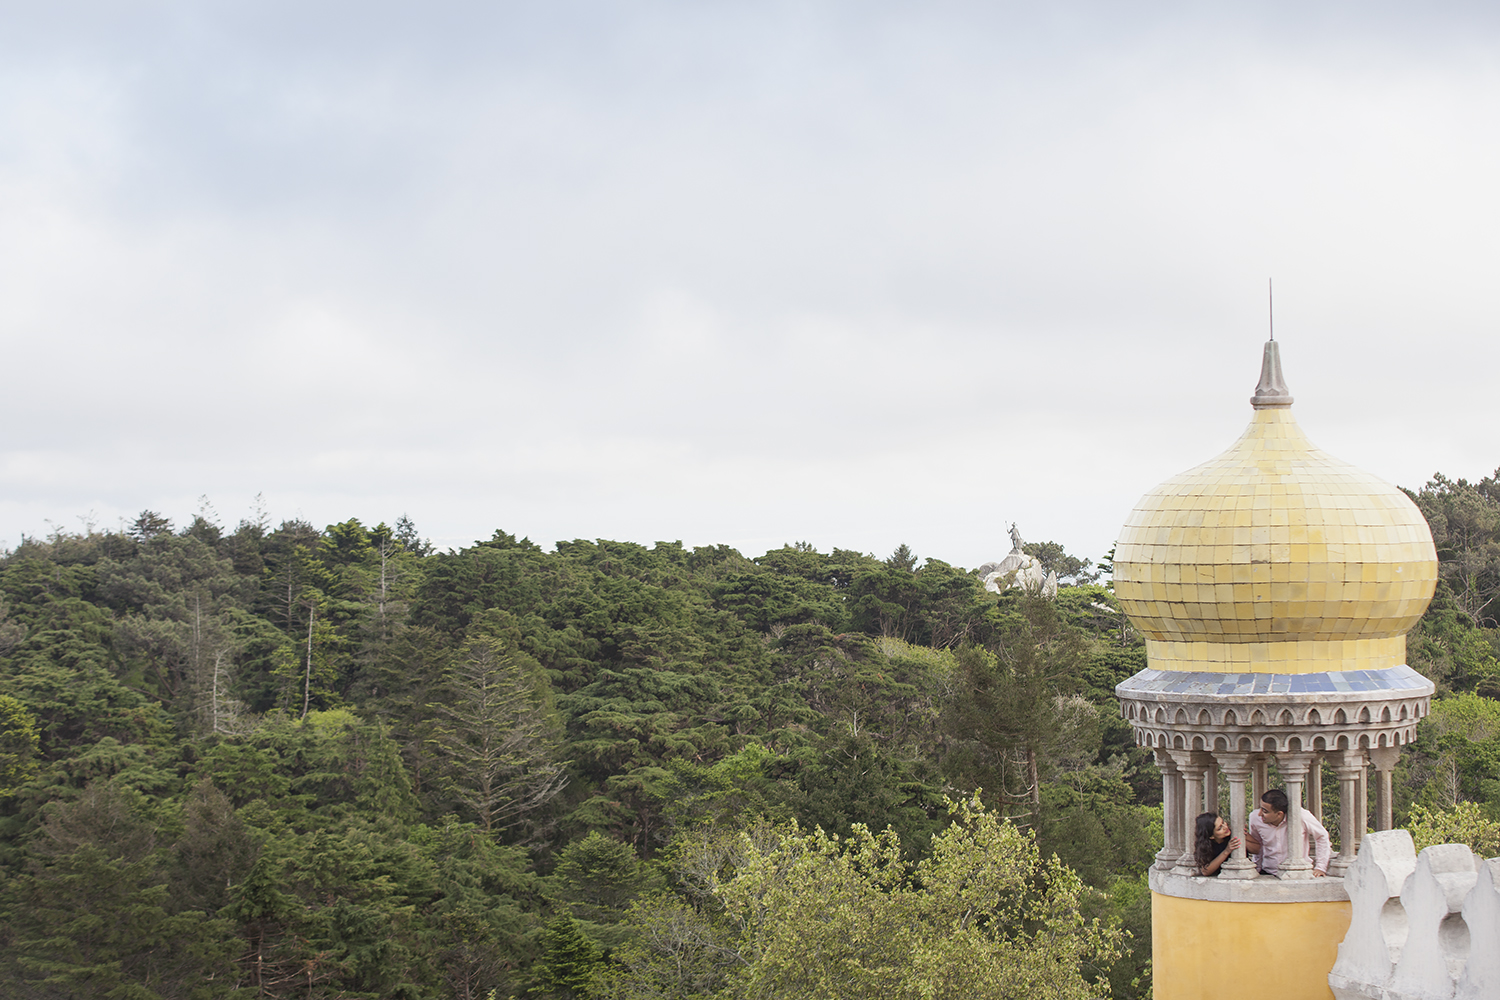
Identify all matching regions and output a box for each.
[0,477,1500,1000]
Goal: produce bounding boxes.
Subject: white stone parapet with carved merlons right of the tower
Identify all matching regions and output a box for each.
[1328,831,1500,1000]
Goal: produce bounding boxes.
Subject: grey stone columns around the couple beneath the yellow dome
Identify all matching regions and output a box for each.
[1155,747,1401,879]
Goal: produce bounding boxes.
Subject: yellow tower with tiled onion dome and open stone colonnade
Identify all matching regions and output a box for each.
[1115,340,1437,1000]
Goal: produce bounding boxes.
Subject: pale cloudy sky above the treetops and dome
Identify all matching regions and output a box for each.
[0,0,1500,567]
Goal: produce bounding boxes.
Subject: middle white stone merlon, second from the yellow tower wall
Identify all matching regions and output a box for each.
[1389,844,1475,1000]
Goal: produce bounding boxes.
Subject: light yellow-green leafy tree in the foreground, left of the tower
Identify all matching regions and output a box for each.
[603,801,1121,1000]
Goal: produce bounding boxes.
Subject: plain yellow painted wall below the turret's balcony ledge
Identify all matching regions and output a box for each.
[1151,892,1349,1000]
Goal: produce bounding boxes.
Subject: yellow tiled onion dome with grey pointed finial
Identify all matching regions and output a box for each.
[1115,345,1437,673]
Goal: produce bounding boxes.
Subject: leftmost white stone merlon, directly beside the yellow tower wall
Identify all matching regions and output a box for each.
[1328,831,1416,997]
